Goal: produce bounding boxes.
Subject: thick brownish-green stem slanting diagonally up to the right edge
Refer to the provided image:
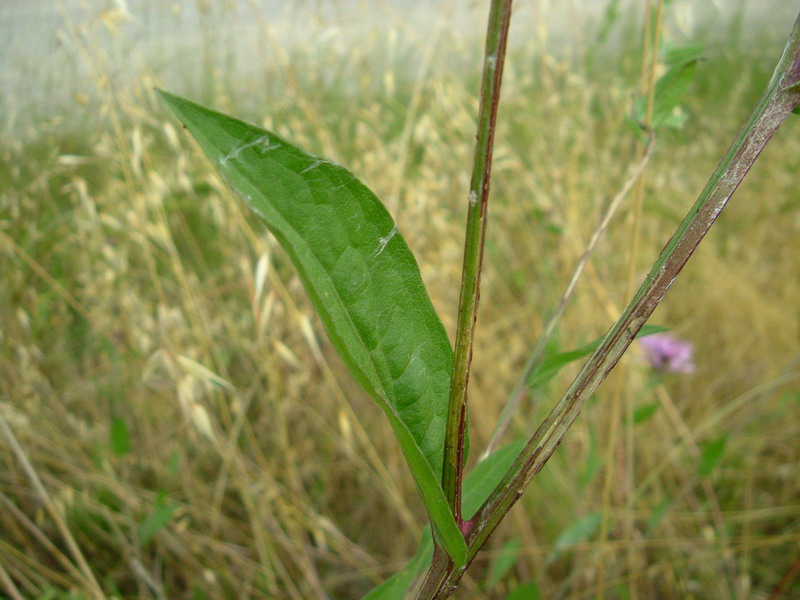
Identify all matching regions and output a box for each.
[416,11,800,600]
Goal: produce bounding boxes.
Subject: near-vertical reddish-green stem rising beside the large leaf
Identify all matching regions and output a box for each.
[442,0,512,526]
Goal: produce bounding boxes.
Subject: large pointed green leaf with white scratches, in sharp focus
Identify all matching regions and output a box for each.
[159,91,466,565]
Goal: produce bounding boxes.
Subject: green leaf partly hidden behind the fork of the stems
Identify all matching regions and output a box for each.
[362,440,525,600]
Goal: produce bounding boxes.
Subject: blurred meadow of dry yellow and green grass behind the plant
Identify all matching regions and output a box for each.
[0,1,800,600]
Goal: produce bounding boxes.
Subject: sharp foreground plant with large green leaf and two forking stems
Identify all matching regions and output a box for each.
[156,5,800,600]
